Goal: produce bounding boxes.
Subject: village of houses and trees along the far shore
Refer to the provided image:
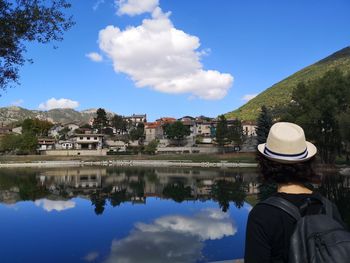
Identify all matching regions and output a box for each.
[0,109,256,156]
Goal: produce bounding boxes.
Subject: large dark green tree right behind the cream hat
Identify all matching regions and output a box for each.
[282,70,350,163]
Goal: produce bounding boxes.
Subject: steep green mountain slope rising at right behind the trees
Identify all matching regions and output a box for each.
[225,46,350,121]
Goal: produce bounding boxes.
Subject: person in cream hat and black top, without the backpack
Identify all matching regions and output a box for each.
[245,122,342,263]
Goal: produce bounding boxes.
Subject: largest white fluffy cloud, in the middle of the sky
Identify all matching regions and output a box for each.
[99,7,233,99]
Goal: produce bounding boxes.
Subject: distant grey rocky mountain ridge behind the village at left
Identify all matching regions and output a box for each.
[0,106,115,125]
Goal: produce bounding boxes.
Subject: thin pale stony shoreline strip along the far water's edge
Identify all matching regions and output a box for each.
[0,160,258,168]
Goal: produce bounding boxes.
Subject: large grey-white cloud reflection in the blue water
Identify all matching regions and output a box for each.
[106,209,237,263]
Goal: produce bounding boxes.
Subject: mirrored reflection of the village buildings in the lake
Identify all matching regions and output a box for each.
[38,168,258,204]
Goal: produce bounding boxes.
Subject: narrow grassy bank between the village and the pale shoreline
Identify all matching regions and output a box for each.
[0,153,255,163]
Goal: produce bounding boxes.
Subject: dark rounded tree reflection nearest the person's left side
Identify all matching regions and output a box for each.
[211,178,246,212]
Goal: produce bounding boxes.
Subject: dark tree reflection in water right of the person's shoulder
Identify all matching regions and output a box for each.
[319,174,350,227]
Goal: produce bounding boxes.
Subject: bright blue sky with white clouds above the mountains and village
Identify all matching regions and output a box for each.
[0,0,350,120]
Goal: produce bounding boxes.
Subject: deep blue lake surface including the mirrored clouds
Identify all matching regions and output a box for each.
[0,168,251,263]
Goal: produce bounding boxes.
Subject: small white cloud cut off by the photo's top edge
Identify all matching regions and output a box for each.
[115,0,159,16]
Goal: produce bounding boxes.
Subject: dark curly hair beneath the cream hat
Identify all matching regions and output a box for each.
[257,153,320,185]
